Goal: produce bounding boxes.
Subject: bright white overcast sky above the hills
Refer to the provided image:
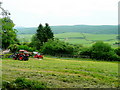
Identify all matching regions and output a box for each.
[0,0,120,27]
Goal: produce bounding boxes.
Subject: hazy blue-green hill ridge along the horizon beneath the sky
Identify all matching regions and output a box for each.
[16,25,118,34]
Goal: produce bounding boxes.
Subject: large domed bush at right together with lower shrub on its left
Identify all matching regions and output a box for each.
[80,41,120,61]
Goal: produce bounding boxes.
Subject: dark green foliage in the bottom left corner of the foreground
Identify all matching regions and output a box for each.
[3,77,47,89]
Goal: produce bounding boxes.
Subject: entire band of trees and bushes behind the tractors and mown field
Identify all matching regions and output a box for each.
[0,18,120,61]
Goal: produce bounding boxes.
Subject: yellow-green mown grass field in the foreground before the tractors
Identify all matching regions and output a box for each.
[2,56,118,88]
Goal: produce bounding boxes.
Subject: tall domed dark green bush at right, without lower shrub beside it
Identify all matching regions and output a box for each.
[91,41,120,61]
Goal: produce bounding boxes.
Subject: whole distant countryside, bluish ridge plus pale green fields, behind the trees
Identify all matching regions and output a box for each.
[16,25,118,47]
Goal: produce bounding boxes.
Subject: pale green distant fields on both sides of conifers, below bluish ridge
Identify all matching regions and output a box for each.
[18,32,117,47]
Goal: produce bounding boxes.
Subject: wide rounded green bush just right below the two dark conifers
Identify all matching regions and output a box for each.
[42,39,74,55]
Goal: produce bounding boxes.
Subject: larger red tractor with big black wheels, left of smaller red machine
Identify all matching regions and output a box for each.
[13,50,29,61]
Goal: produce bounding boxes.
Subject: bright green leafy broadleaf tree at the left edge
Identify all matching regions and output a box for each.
[0,17,18,49]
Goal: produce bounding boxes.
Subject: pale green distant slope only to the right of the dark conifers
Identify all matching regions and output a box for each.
[54,32,117,47]
